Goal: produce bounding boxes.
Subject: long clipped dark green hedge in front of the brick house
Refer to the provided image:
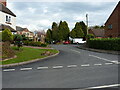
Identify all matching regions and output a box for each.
[87,38,120,51]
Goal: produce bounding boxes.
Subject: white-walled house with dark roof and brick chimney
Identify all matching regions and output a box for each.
[0,0,16,34]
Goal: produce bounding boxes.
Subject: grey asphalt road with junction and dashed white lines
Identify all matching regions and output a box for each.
[2,45,119,90]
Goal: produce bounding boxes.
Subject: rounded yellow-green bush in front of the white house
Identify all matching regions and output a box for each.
[2,28,13,42]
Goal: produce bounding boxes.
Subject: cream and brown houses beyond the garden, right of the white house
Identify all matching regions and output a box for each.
[16,26,38,41]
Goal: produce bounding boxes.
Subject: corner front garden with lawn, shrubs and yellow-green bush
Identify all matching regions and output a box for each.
[0,29,59,65]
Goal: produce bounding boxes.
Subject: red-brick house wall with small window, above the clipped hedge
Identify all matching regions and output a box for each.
[105,1,120,37]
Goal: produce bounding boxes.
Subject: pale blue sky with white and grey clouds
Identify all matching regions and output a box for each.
[7,0,118,31]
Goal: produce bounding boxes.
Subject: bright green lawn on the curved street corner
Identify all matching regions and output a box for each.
[2,47,58,65]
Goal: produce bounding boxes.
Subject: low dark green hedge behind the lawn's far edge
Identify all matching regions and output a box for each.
[23,41,47,47]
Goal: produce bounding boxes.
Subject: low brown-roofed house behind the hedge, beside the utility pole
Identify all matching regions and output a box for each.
[88,28,105,38]
